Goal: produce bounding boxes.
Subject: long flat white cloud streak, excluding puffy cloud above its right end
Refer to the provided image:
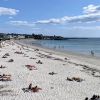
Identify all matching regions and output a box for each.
[36,13,100,24]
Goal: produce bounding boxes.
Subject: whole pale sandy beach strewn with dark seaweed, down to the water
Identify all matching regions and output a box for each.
[0,41,100,100]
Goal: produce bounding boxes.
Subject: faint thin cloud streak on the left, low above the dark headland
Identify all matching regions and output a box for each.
[8,21,35,27]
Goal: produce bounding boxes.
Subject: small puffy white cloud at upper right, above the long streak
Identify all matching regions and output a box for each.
[83,4,100,14]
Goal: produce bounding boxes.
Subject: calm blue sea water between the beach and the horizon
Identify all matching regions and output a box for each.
[32,38,100,56]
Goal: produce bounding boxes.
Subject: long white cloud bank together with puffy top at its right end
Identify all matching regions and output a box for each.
[35,5,100,24]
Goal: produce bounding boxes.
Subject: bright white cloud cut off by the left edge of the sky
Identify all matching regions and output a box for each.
[0,7,19,16]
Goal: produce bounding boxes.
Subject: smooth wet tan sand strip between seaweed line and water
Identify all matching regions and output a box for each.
[15,39,100,66]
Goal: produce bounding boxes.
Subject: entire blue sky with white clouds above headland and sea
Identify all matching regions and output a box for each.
[0,0,100,37]
